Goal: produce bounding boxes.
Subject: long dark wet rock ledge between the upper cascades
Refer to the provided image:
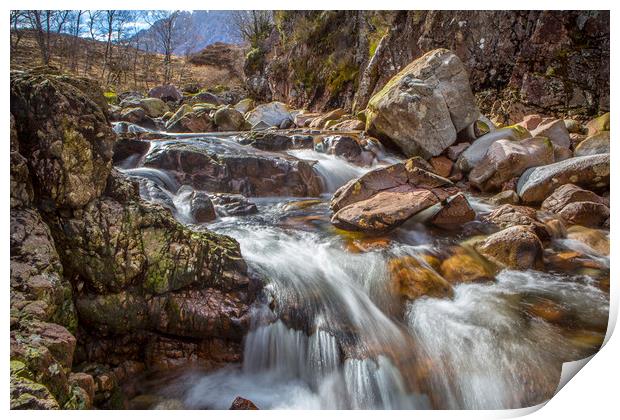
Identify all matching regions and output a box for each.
[144,139,322,197]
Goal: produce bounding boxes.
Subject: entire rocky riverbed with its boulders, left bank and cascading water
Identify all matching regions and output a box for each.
[11,46,610,409]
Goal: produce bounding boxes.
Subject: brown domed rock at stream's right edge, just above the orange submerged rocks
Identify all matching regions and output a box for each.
[474,226,543,270]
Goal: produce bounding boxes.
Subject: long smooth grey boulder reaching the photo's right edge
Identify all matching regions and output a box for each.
[517,154,609,203]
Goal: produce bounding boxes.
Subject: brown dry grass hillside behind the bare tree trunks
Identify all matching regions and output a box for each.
[11,31,244,92]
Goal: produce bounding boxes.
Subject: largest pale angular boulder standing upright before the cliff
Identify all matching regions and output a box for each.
[366,49,479,157]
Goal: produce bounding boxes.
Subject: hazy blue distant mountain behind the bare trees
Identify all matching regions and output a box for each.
[139,10,243,55]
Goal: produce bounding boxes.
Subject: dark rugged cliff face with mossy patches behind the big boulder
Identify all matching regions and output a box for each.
[246,11,609,120]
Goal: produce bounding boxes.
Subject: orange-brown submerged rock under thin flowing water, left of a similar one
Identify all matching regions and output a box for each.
[388,256,454,300]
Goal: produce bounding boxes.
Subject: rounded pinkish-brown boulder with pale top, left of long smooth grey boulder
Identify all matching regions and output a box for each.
[469,137,554,191]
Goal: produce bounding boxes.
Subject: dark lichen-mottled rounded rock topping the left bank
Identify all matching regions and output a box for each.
[11,72,116,208]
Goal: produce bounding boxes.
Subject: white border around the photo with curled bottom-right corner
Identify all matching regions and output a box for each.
[0,0,620,420]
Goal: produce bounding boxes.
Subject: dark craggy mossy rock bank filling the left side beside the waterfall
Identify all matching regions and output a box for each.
[10,72,253,409]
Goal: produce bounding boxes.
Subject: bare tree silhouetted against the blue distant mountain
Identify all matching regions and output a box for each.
[146,10,181,83]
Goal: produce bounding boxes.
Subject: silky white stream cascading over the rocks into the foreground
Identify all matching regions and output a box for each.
[118,132,609,409]
